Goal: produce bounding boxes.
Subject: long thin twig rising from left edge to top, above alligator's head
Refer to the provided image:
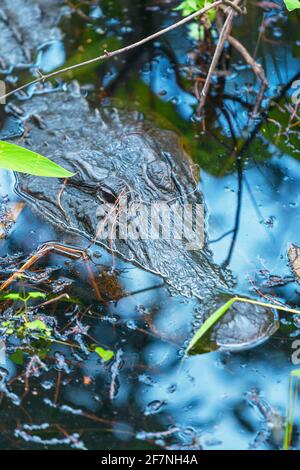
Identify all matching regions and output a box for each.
[0,0,223,101]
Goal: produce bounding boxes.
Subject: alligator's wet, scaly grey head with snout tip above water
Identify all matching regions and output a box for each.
[7,91,277,347]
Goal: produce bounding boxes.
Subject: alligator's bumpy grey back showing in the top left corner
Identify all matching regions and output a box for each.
[0,0,65,72]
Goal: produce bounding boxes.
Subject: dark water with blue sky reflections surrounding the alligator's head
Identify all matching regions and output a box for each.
[0,0,300,449]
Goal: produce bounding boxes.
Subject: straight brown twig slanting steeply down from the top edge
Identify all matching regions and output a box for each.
[199,0,241,114]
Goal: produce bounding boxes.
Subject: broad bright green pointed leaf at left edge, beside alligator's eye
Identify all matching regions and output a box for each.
[0,140,74,178]
